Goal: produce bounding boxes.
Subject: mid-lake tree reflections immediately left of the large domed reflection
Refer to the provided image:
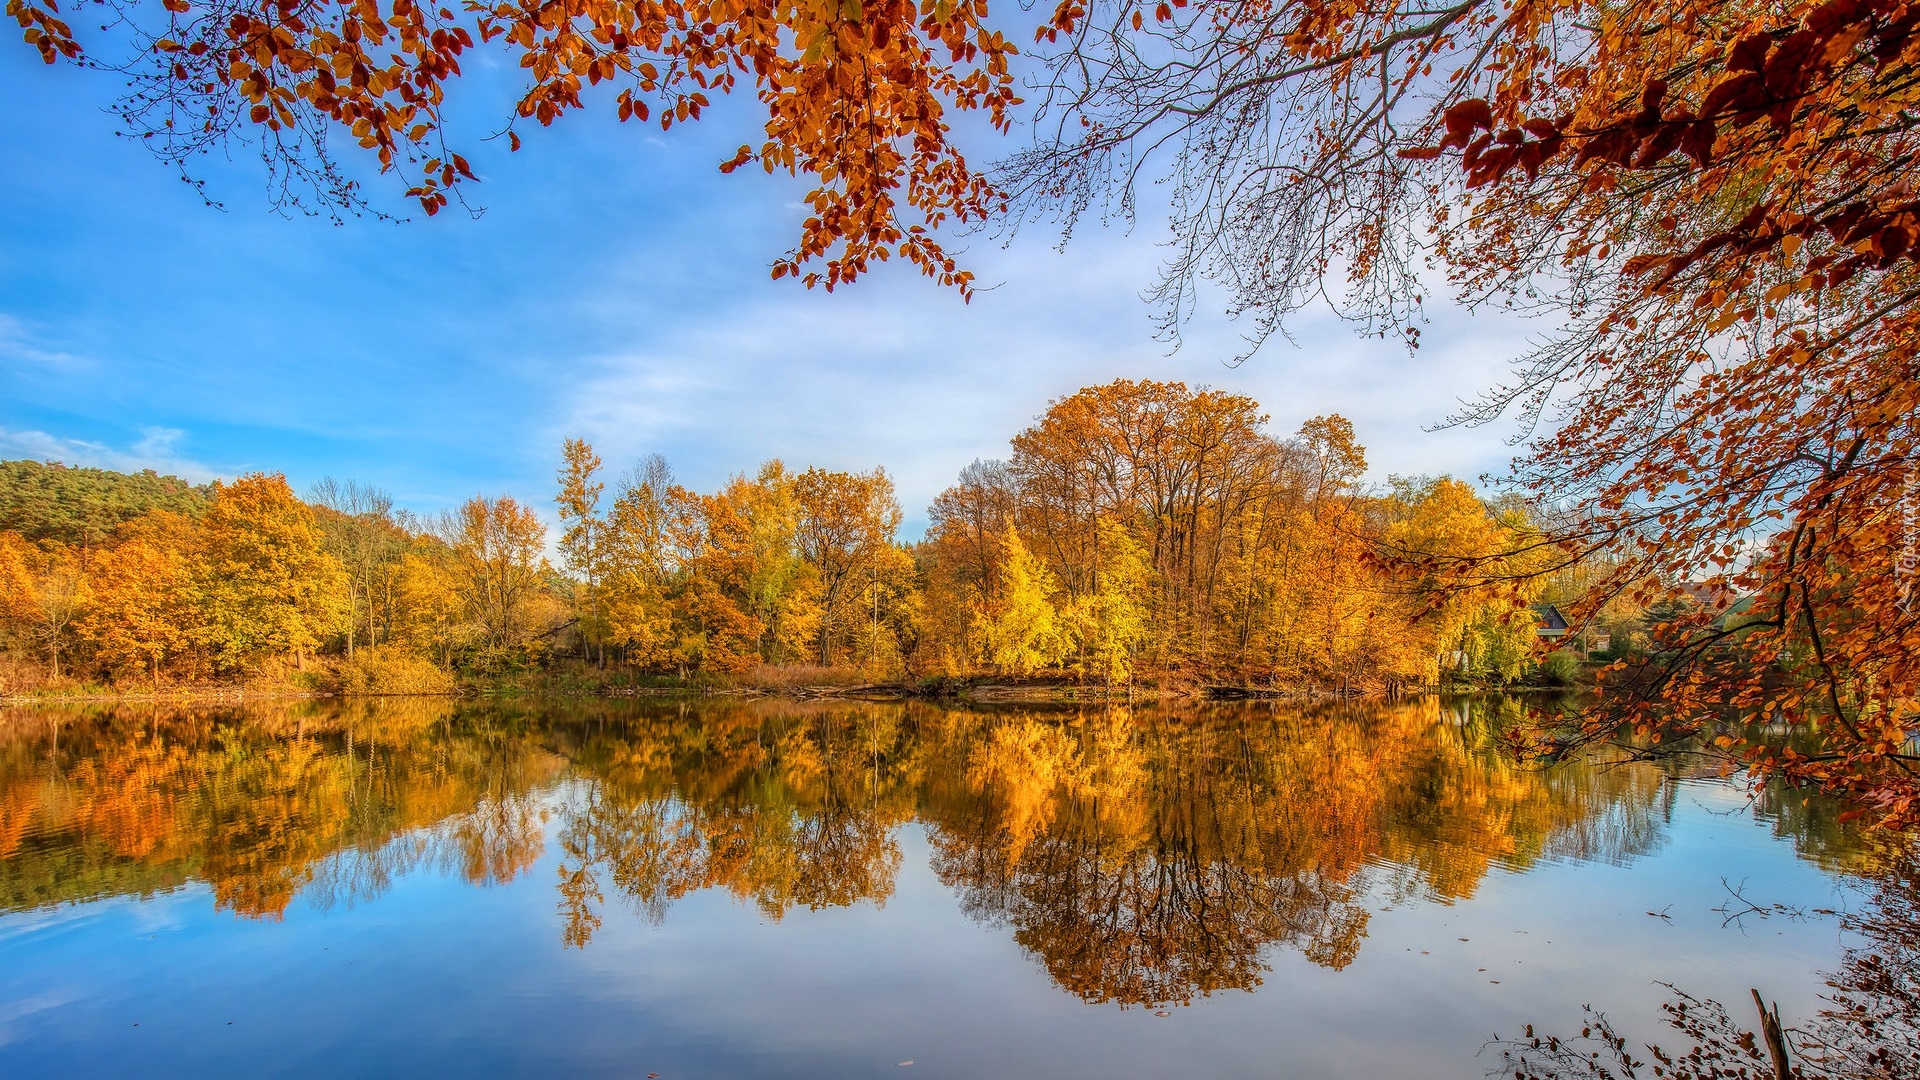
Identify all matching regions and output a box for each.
[559,707,912,945]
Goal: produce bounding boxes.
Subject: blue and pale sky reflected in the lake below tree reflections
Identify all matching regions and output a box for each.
[0,707,1873,1078]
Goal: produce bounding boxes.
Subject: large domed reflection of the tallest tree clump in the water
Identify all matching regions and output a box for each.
[927,715,1367,1003]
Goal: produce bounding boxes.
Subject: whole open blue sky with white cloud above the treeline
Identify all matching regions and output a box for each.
[0,42,1528,534]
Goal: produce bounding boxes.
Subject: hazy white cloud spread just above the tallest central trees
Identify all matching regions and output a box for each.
[541,223,1528,532]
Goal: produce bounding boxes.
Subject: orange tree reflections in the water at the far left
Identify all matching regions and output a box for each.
[0,701,561,919]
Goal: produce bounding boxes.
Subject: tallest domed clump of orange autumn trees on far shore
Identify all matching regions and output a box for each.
[918,380,1478,690]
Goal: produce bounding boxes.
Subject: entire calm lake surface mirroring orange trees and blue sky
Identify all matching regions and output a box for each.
[0,701,1868,1080]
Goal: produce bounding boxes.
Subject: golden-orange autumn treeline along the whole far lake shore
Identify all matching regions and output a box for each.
[0,380,1574,692]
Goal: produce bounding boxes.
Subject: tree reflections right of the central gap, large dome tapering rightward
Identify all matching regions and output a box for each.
[924,701,1661,1003]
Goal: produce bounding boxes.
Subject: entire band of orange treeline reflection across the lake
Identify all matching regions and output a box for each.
[0,700,1797,1005]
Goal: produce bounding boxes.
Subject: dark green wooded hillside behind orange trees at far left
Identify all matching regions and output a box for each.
[0,461,213,544]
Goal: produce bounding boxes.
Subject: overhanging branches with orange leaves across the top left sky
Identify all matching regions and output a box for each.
[6,0,1020,294]
